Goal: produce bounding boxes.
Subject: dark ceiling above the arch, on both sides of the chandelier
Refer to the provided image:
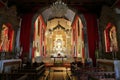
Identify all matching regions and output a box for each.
[2,0,120,15]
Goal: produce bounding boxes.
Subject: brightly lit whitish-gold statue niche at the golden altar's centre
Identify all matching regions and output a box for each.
[53,35,65,57]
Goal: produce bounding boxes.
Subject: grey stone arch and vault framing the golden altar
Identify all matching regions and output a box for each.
[29,1,89,63]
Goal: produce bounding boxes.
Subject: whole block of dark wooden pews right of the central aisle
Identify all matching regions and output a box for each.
[67,62,115,80]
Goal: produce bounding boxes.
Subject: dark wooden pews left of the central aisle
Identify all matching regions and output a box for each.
[16,63,46,80]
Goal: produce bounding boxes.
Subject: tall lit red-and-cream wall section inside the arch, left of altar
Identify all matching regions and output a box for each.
[32,15,46,60]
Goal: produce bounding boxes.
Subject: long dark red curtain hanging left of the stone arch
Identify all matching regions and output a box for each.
[20,13,33,57]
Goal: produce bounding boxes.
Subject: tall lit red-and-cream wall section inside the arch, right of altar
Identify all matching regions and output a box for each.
[72,16,85,60]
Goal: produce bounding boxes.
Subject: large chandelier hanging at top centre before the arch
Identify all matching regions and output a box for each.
[51,0,68,17]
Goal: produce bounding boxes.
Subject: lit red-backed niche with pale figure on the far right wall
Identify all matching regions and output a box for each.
[104,23,118,52]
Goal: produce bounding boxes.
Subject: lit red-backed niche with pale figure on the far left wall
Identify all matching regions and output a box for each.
[0,23,14,52]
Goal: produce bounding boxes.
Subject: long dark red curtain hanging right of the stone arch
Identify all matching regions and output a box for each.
[84,13,99,65]
